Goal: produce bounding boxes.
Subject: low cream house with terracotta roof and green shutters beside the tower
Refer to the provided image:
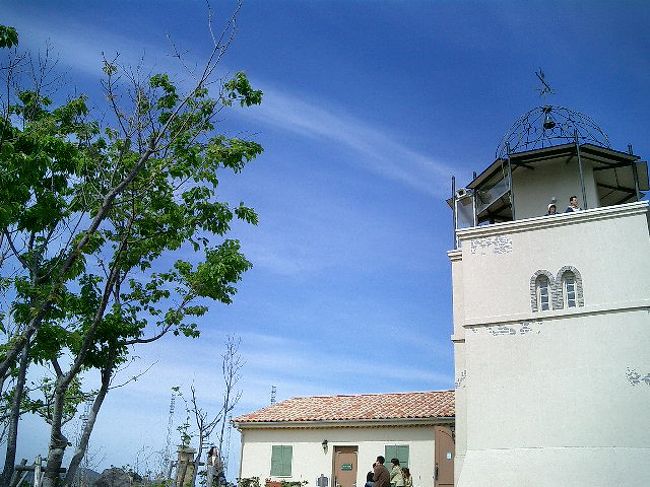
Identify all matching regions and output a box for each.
[233,391,454,487]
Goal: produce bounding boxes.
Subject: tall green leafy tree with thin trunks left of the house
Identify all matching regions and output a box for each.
[0,8,262,486]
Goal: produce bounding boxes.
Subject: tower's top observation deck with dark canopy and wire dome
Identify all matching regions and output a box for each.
[447,105,650,248]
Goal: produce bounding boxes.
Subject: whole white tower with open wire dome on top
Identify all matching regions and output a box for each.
[448,105,650,487]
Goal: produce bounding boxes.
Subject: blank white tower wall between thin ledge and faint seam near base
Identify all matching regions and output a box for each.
[465,310,650,448]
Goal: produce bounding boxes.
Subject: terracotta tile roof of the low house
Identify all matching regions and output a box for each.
[233,391,454,424]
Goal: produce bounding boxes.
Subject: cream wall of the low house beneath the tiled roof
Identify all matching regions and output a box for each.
[240,426,435,487]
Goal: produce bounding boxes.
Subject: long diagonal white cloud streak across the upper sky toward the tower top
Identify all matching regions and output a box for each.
[6,10,453,197]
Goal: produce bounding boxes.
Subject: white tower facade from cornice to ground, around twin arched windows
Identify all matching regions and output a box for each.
[449,200,650,487]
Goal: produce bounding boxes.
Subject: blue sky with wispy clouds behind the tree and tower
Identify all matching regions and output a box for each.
[0,0,650,477]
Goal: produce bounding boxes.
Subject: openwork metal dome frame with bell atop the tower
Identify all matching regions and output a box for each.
[495,105,610,159]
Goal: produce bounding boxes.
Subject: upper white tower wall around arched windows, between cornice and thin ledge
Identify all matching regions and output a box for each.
[459,203,650,326]
